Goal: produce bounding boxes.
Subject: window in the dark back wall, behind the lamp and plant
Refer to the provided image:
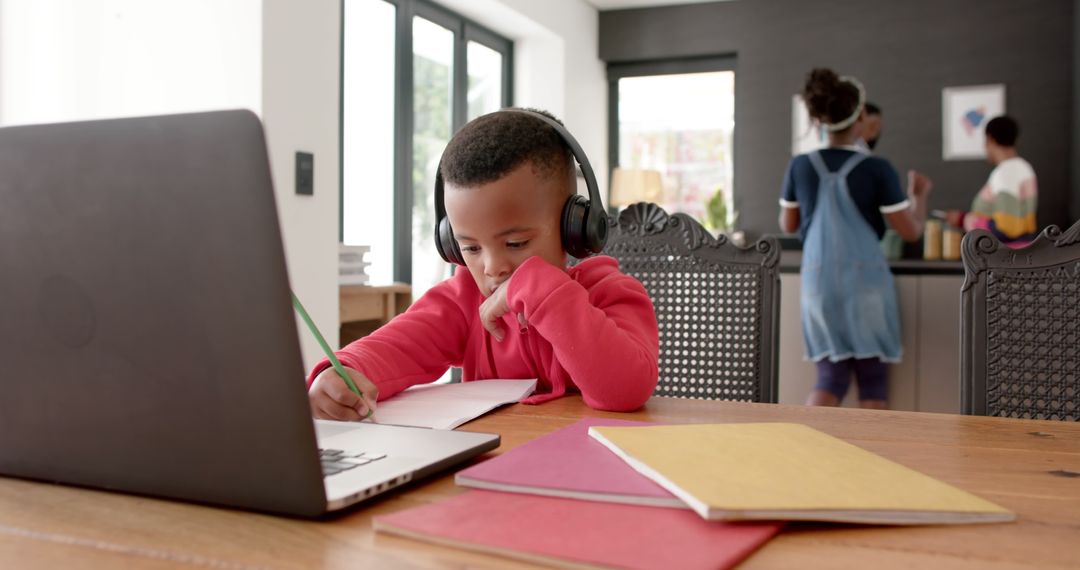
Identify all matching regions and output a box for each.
[608,58,734,230]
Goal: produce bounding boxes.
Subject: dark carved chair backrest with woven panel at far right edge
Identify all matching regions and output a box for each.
[960,221,1080,421]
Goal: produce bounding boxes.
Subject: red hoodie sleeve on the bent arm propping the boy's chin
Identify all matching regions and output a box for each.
[507,257,660,411]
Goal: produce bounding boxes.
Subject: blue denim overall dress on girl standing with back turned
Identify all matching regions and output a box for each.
[800,152,902,363]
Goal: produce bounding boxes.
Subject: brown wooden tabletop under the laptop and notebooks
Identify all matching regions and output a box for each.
[0,396,1080,570]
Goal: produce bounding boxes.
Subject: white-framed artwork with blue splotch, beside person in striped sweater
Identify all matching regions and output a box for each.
[942,84,1005,160]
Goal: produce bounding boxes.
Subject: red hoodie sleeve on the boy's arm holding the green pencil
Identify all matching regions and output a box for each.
[308,271,475,401]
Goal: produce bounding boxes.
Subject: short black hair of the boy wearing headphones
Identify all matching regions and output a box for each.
[441,109,575,192]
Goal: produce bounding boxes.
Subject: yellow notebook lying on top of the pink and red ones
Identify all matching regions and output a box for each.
[589,423,1016,525]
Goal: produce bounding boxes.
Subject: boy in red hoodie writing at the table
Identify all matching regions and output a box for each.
[308,110,659,420]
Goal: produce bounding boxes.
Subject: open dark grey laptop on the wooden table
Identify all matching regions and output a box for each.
[0,111,499,516]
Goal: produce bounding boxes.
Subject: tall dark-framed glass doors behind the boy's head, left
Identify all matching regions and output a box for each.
[341,0,512,298]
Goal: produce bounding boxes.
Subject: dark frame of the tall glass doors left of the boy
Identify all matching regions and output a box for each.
[338,0,514,284]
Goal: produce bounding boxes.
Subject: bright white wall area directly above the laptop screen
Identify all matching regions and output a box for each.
[0,0,261,125]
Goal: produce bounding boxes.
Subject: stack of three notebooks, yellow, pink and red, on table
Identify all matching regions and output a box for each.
[375,418,1015,569]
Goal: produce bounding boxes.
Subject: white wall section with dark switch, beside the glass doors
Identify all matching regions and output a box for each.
[262,0,341,368]
